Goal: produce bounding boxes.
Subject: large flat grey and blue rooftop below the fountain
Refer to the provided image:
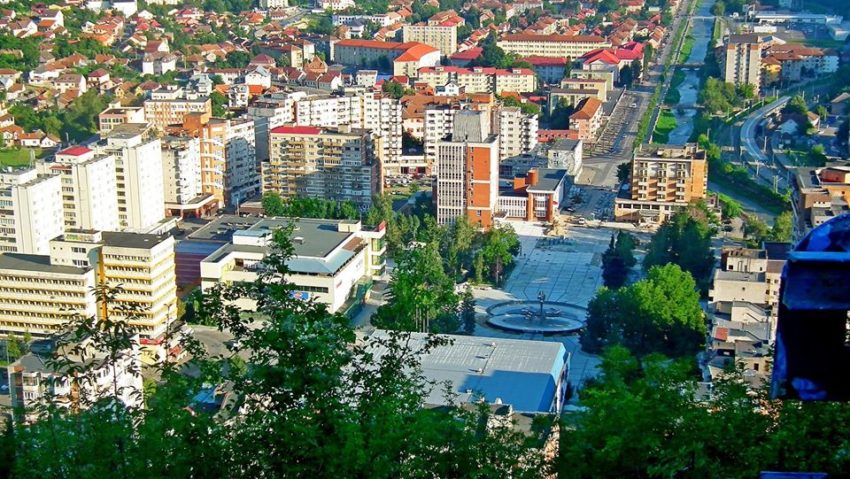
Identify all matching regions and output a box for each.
[359,330,566,412]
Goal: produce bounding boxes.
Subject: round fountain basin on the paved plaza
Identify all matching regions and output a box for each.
[487,291,587,334]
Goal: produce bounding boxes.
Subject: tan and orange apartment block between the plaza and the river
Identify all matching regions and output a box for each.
[614,143,708,223]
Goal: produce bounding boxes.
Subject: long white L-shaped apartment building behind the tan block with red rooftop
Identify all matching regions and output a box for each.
[295,88,403,174]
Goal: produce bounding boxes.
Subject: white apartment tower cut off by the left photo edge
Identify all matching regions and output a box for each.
[0,168,65,254]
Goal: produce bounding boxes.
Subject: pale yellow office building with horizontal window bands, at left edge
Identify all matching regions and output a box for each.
[0,230,177,360]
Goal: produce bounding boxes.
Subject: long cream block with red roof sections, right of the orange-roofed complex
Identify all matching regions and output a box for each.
[419,66,537,95]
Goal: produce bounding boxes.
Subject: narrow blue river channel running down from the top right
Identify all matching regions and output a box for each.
[669,0,715,145]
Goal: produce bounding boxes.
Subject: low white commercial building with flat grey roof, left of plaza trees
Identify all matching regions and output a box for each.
[197,216,386,313]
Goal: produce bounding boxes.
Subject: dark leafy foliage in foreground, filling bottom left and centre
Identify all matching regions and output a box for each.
[0,230,547,479]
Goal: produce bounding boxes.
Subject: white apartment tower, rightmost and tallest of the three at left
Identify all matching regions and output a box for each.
[98,123,165,232]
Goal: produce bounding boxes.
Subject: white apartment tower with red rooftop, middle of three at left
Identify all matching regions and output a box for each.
[37,146,120,231]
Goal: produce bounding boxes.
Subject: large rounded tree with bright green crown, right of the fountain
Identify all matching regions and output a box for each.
[581,264,706,357]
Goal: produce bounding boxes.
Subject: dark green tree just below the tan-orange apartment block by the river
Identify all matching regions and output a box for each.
[643,207,714,293]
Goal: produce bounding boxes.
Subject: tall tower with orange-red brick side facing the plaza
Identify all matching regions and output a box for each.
[435,110,499,229]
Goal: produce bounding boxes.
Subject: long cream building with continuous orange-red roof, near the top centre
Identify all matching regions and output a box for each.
[497,33,611,58]
